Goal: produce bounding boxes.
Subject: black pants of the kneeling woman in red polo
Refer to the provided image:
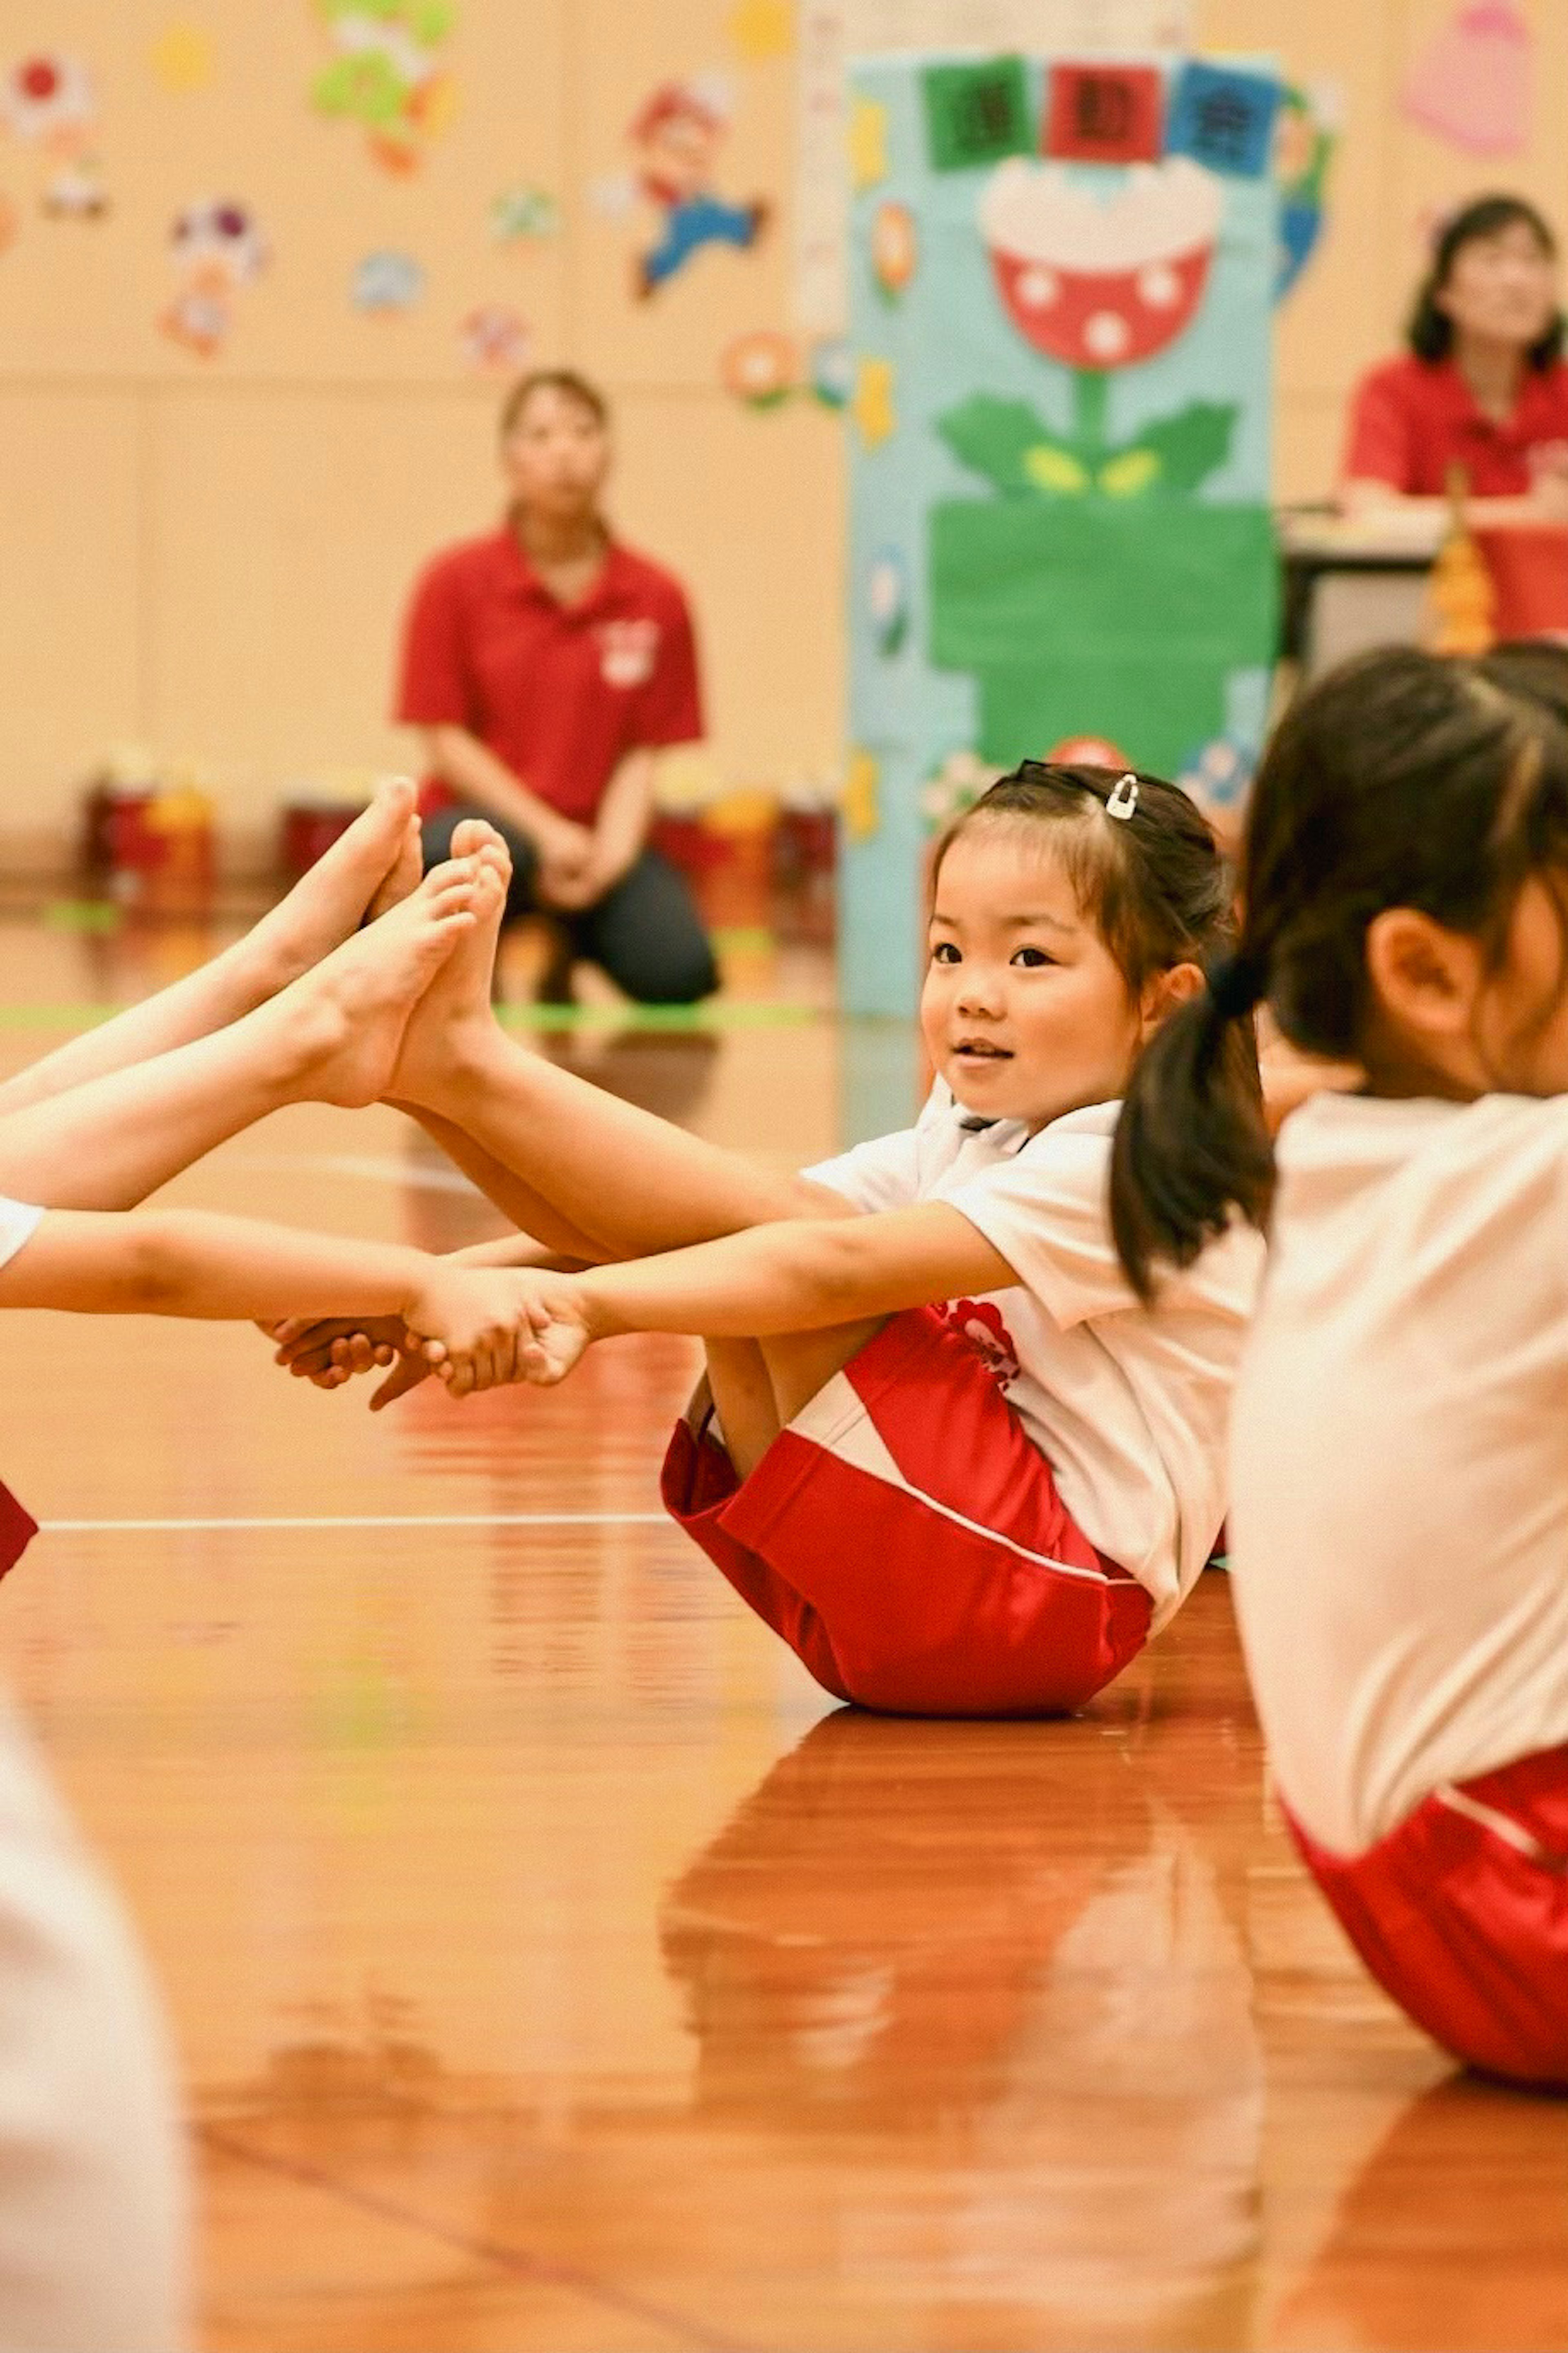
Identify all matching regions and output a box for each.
[424,807,718,1005]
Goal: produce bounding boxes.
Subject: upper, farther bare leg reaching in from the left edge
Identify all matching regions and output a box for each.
[0,779,419,1118]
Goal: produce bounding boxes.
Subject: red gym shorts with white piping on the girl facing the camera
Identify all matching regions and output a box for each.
[664,1308,1149,1715]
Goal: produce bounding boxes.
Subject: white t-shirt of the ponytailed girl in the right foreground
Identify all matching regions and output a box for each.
[1229,1094,1568,1854]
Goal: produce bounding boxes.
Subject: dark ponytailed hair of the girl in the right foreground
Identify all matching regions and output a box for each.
[1111,647,1568,1299]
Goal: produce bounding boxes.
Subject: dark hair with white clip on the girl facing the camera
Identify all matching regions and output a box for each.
[930,760,1260,1094]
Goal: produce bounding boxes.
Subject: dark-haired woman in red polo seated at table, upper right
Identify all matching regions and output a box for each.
[1342,195,1568,638]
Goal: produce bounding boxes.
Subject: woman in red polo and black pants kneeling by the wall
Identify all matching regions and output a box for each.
[398,370,718,1005]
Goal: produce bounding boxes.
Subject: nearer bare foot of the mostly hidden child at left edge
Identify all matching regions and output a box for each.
[264,859,492,1106]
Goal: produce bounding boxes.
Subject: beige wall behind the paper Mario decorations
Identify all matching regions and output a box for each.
[0,0,1568,864]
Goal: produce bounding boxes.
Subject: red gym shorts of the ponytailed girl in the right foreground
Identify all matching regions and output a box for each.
[1285,1748,1568,2090]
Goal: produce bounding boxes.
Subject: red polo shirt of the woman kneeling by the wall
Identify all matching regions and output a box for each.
[398,527,702,826]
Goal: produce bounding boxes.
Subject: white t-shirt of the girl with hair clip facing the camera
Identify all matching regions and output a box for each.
[805,1080,1262,1626]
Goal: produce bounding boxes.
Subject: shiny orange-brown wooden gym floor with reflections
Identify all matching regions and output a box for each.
[0,889,1568,2353]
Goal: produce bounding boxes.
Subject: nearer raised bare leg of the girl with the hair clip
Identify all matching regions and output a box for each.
[391,826,848,1259]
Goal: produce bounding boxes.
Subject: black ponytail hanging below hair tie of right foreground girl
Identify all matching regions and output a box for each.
[1111,953,1274,1304]
